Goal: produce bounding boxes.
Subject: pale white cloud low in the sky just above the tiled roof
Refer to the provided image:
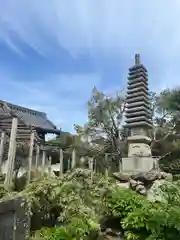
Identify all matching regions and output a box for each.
[0,70,101,131]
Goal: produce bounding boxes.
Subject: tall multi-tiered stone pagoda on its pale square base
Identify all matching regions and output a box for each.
[122,54,154,171]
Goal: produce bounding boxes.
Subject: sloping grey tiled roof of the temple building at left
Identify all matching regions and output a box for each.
[1,101,60,134]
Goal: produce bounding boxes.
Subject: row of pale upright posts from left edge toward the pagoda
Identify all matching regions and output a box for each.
[0,118,115,188]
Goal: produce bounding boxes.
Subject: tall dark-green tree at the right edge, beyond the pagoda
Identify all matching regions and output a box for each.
[152,88,180,155]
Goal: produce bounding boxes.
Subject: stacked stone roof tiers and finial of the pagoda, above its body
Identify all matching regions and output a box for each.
[125,54,152,129]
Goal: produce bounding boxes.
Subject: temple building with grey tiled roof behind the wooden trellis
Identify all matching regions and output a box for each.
[0,100,61,171]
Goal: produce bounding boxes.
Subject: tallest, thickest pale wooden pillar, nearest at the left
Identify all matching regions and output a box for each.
[4,118,18,187]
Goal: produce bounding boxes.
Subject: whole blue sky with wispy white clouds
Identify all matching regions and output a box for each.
[0,0,180,131]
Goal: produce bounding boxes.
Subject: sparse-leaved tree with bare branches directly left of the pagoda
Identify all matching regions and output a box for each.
[75,88,125,172]
